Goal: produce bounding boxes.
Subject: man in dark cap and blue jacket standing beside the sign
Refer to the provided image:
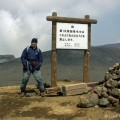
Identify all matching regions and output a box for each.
[20,38,44,96]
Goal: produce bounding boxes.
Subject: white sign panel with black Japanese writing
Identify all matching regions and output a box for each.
[56,23,88,49]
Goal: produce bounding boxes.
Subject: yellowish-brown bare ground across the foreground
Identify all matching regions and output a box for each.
[0,83,120,120]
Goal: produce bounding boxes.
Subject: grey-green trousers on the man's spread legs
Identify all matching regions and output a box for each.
[20,70,44,92]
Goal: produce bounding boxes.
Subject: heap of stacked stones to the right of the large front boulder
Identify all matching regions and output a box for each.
[94,63,120,106]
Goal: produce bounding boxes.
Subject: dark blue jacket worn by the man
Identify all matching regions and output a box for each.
[21,46,43,71]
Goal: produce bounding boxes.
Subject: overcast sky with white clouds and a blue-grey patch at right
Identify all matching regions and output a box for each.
[0,0,120,57]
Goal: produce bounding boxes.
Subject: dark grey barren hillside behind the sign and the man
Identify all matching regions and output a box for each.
[0,44,120,86]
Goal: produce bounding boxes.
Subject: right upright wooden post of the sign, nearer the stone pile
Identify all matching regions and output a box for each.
[83,15,91,83]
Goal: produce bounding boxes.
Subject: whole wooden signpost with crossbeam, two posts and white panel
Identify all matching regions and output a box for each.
[46,12,97,87]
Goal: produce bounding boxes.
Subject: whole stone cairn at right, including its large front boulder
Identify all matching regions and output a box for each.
[78,63,120,108]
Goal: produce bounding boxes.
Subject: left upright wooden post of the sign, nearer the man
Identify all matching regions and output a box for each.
[51,12,57,87]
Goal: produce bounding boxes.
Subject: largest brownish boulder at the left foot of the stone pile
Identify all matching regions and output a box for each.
[78,92,99,108]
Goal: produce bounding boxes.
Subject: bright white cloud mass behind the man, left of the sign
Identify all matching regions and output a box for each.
[0,6,51,57]
